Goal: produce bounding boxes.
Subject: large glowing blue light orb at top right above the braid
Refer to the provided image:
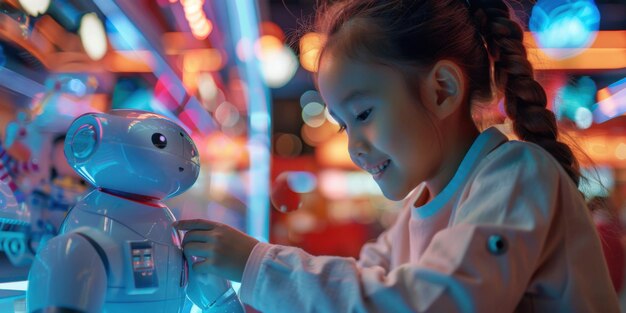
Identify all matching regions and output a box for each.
[528,0,600,60]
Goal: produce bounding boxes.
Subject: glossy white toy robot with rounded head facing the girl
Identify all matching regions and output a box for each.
[27,110,244,313]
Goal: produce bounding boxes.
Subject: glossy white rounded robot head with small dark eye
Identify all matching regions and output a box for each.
[65,110,200,199]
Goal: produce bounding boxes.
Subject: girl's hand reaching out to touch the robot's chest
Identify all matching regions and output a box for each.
[173,219,258,282]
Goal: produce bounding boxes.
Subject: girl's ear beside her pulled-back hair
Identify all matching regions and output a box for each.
[422,60,466,120]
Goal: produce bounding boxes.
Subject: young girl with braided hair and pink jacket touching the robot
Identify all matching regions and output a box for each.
[177,0,619,312]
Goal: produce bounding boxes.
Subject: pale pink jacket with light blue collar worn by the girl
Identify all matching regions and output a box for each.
[240,128,619,313]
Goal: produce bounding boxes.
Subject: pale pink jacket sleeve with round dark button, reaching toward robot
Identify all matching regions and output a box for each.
[241,143,563,312]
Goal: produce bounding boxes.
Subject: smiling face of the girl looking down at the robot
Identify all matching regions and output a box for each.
[318,54,442,200]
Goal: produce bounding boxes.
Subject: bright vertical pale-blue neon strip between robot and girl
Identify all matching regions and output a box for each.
[227,0,271,241]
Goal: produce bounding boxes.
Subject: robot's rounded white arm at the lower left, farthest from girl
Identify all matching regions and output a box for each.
[26,232,107,313]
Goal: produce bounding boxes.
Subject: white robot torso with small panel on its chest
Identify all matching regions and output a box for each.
[61,190,187,313]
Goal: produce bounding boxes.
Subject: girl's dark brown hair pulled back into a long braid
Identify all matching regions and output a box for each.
[315,0,580,184]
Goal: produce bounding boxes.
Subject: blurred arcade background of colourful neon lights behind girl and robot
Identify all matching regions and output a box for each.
[0,0,626,312]
